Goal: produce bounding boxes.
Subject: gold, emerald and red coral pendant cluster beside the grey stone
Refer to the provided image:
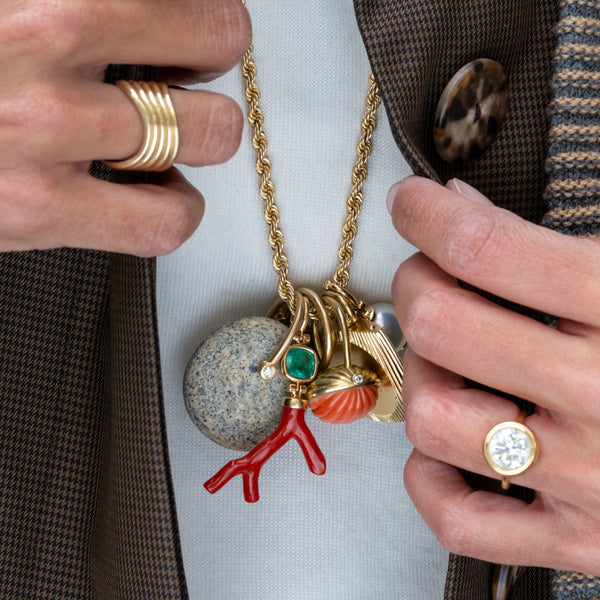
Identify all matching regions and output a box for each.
[199,283,404,502]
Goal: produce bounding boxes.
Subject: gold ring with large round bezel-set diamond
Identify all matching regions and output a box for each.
[483,412,539,490]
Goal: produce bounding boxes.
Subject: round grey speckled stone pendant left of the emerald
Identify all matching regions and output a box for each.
[183,317,289,450]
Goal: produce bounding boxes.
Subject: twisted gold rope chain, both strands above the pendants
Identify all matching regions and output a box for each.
[241,17,381,314]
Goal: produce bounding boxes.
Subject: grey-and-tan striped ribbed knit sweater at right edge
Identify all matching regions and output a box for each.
[543,0,600,600]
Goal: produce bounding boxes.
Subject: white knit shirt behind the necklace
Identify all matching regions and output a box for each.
[158,0,447,600]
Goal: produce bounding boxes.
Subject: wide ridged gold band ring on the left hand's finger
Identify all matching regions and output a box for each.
[104,80,179,171]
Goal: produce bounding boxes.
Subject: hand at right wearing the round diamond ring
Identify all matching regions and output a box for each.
[390,177,600,575]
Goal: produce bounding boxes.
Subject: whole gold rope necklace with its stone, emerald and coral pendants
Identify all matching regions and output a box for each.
[184,0,404,502]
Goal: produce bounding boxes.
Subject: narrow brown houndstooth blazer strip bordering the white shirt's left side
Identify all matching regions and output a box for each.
[92,67,187,600]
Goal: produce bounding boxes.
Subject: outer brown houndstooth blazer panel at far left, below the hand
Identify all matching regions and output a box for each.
[0,249,108,600]
